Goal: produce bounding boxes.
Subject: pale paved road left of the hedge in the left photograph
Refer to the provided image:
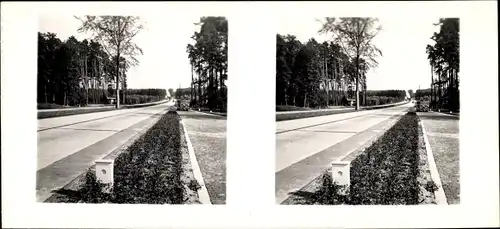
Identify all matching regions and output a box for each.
[36,103,172,201]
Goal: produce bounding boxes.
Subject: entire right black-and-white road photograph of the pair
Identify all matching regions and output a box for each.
[275,17,460,205]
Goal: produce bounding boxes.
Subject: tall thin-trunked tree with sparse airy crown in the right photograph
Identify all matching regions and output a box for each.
[319,17,382,110]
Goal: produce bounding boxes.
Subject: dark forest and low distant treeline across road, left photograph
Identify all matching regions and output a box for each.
[37,32,166,106]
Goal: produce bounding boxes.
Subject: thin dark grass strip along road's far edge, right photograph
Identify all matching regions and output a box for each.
[276,103,408,122]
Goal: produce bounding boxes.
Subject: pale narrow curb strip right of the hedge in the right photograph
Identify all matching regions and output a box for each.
[418,120,448,205]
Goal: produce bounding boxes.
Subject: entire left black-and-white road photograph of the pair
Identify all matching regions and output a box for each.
[36,15,228,204]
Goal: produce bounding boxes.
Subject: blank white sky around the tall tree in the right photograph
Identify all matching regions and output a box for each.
[278,17,438,90]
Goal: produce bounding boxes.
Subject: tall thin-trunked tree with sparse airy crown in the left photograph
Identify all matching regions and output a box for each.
[77,16,143,108]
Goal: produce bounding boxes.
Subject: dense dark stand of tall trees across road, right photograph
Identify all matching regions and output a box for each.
[276,34,382,107]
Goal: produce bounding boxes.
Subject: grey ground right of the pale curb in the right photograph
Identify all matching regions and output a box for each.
[417,112,460,204]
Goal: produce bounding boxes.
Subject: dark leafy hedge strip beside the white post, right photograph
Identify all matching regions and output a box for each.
[313,112,437,205]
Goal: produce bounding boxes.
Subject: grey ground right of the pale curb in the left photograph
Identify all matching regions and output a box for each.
[177,111,227,204]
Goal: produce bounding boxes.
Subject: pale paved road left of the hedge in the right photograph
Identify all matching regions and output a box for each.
[275,103,413,203]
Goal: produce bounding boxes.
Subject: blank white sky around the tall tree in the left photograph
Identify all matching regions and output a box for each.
[39,15,199,89]
